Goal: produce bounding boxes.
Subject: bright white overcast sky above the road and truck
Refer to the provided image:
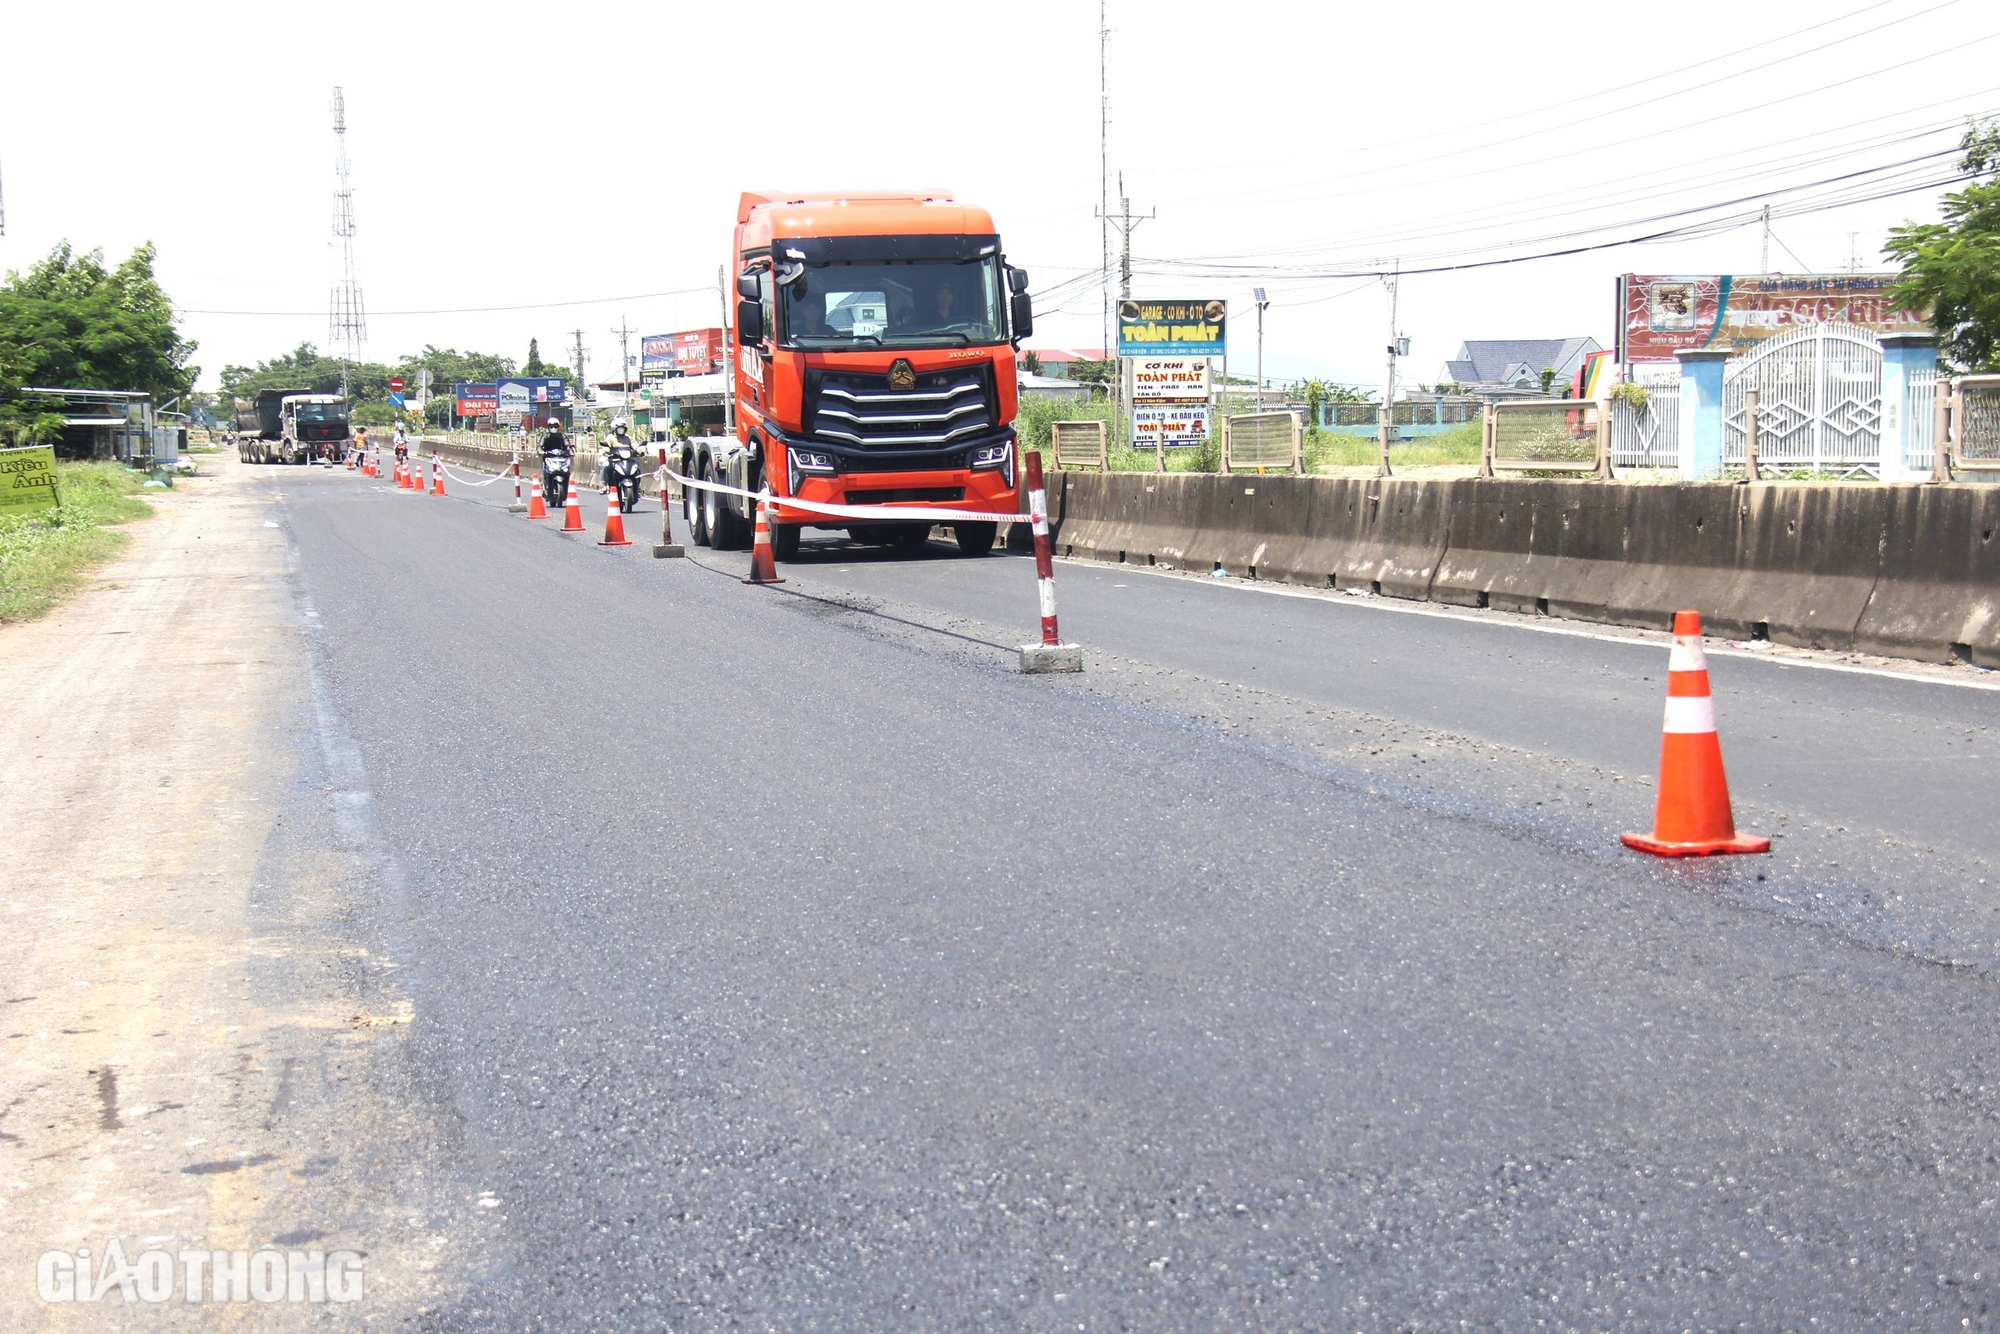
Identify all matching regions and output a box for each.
[0,0,2000,388]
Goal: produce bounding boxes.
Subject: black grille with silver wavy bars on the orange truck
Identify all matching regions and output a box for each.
[806,362,998,454]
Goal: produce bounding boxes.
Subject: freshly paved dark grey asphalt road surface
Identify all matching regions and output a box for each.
[270,470,2000,1330]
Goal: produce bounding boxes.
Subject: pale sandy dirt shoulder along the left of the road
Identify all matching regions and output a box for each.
[0,454,472,1330]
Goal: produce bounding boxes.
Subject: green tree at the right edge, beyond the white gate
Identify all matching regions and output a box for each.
[1884,120,2000,372]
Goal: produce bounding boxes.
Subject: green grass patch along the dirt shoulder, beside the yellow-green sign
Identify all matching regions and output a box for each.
[0,464,152,622]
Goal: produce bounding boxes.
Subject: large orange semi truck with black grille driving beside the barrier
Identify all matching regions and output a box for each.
[680,190,1034,560]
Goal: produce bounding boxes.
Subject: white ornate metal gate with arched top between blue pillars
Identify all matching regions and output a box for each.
[1722,322,1882,474]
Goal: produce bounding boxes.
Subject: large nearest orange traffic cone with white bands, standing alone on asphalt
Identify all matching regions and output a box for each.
[1624,612,1770,856]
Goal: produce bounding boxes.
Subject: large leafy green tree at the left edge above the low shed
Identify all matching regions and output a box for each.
[0,242,200,442]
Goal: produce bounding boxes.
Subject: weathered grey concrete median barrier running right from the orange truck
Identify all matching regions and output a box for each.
[1052,474,2000,666]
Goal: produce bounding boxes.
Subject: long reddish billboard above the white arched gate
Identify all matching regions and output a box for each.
[1618,274,1930,362]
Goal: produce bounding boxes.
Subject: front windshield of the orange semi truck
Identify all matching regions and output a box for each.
[778,256,1006,348]
